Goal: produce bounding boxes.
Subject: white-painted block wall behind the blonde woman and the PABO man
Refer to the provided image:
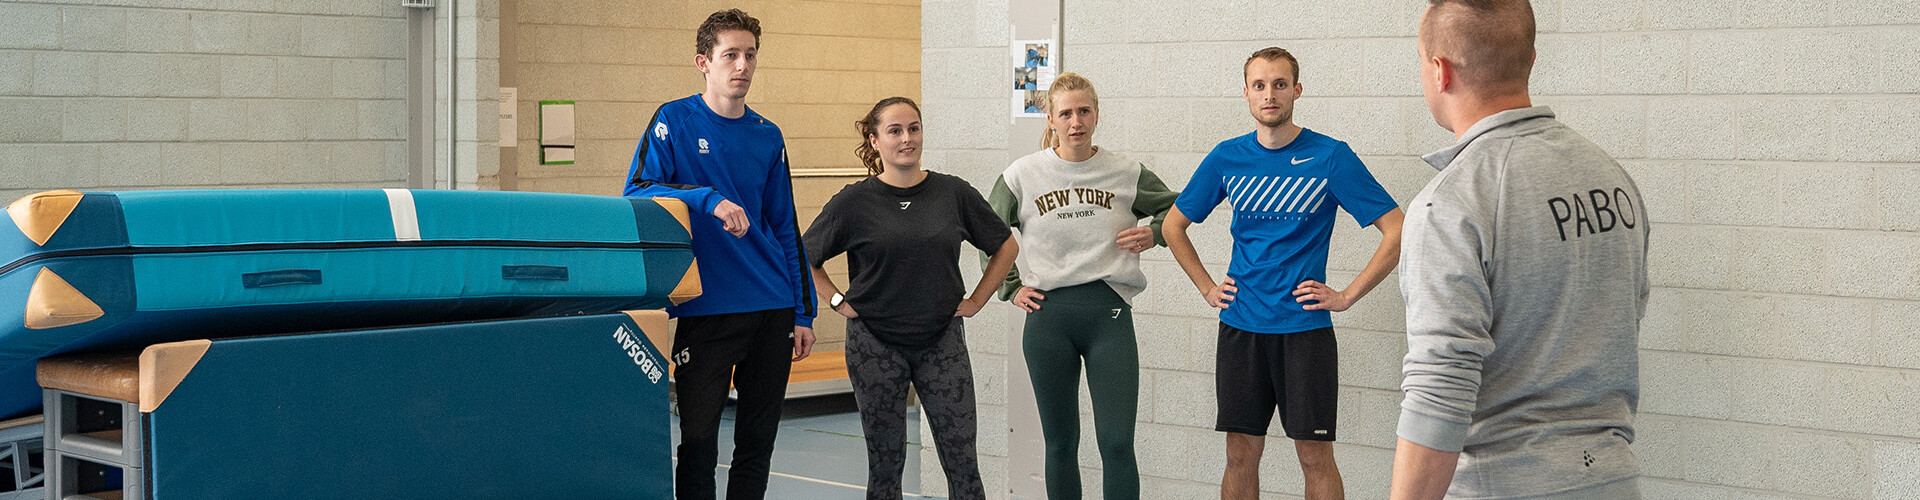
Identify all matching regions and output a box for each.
[925,0,1920,498]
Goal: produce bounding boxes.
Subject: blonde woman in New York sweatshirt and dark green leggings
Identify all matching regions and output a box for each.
[987,73,1179,500]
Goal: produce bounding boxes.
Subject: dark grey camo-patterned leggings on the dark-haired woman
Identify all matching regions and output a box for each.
[847,317,987,500]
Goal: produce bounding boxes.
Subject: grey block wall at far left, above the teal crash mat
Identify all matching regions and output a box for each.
[0,0,407,200]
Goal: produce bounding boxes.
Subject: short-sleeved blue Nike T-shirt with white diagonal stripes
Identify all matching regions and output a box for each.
[1173,129,1400,333]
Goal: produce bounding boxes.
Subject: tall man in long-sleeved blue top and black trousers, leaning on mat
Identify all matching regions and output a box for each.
[626,10,814,500]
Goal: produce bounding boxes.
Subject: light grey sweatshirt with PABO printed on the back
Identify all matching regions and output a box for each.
[1400,106,1649,498]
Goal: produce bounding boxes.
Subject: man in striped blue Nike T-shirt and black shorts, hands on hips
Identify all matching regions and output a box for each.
[1162,46,1402,500]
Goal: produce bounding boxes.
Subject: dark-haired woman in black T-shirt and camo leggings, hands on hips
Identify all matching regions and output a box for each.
[804,98,1020,500]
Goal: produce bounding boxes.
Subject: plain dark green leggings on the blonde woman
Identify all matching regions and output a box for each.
[1023,281,1140,500]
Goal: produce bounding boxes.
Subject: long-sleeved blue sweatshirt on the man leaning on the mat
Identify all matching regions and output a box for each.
[626,94,814,327]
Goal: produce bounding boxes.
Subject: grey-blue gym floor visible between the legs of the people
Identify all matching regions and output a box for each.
[672,394,925,500]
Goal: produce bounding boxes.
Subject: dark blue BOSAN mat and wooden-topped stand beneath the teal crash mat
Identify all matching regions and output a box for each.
[38,312,672,500]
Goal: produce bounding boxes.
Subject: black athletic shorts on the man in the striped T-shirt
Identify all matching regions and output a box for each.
[1213,323,1340,440]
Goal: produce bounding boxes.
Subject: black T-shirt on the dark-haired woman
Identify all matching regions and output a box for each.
[804,171,1014,346]
